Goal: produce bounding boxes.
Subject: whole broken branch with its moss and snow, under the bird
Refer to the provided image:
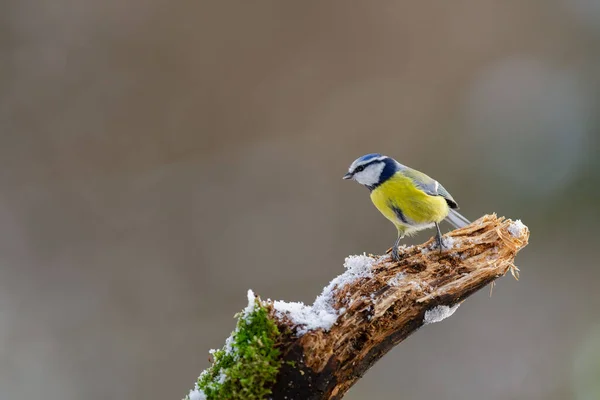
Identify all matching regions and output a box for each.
[186,215,529,400]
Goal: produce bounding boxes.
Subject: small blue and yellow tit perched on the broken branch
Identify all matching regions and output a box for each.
[343,153,470,261]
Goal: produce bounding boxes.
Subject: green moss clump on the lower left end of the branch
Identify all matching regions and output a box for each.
[186,299,281,400]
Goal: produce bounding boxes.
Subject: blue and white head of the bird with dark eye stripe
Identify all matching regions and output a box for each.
[343,153,399,190]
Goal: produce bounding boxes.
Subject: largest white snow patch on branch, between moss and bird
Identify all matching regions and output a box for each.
[273,254,375,335]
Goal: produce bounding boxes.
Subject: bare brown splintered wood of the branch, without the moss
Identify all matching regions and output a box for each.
[268,215,529,400]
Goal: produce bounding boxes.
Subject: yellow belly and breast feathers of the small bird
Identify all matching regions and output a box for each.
[371,173,449,234]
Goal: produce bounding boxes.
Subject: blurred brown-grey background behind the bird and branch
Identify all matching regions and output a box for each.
[0,0,600,400]
